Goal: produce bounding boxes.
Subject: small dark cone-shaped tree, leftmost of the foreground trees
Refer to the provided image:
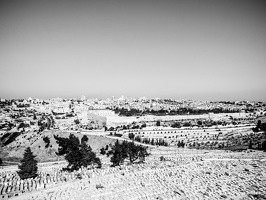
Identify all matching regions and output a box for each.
[17,147,38,179]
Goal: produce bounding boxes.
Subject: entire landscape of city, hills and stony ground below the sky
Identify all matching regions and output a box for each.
[0,95,266,199]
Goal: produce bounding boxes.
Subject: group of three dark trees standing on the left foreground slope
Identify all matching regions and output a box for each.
[15,134,149,179]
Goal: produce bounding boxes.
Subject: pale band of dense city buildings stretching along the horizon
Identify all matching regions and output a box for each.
[0,96,266,133]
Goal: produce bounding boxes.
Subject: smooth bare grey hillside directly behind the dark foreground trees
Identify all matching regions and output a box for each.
[0,130,115,161]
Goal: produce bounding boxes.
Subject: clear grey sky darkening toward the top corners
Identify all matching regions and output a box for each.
[0,0,266,101]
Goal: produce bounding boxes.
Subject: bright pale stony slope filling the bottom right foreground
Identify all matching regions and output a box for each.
[2,147,266,200]
